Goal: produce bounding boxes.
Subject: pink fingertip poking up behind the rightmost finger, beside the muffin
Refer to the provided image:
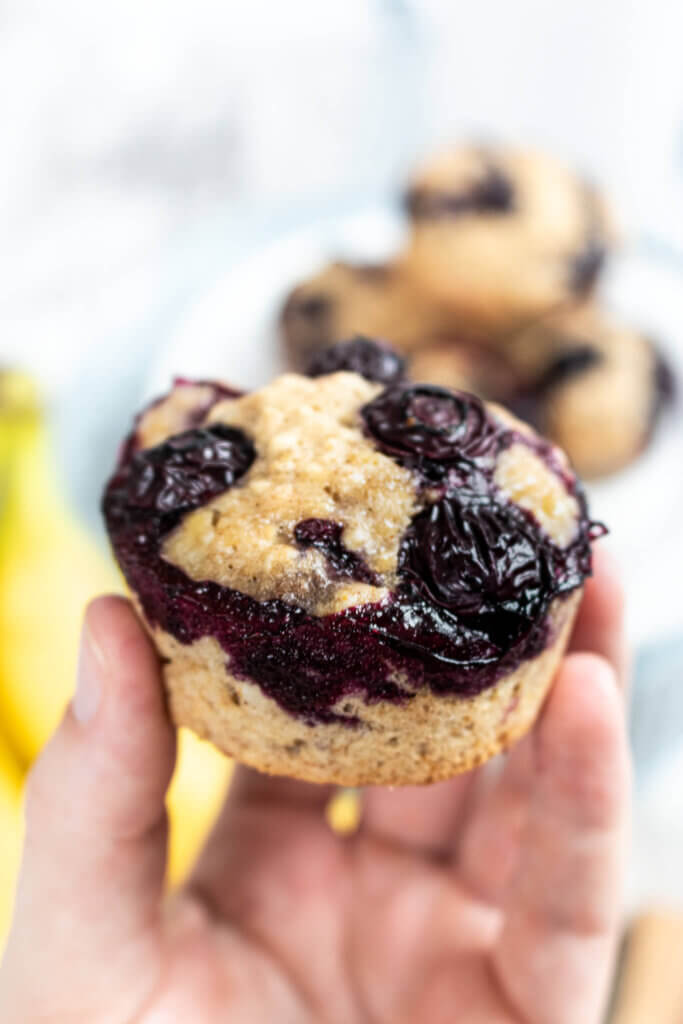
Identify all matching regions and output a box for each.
[569,545,628,687]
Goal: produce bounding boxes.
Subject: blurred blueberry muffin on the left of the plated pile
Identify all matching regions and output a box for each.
[280,261,453,370]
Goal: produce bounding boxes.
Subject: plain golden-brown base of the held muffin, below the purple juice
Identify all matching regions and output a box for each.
[138,590,582,785]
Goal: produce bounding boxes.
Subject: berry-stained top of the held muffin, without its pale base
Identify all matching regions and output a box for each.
[103,340,595,720]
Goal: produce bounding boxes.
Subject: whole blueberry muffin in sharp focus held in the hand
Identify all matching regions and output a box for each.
[103,337,599,785]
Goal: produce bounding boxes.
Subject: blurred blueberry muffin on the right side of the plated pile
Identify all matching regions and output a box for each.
[508,306,673,477]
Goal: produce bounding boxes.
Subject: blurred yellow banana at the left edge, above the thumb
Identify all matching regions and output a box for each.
[0,372,122,765]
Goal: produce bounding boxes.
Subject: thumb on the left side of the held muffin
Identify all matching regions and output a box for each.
[4,597,175,1020]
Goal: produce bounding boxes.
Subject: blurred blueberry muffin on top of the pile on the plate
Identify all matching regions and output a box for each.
[403,146,612,330]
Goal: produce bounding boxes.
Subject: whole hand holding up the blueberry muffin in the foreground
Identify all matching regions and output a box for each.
[0,551,629,1024]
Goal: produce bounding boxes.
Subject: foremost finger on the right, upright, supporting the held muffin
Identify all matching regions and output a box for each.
[494,654,629,1024]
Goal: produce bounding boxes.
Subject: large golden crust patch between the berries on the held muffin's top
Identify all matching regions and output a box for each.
[164,373,420,615]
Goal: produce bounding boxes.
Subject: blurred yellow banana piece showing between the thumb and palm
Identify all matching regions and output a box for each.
[166,729,232,886]
